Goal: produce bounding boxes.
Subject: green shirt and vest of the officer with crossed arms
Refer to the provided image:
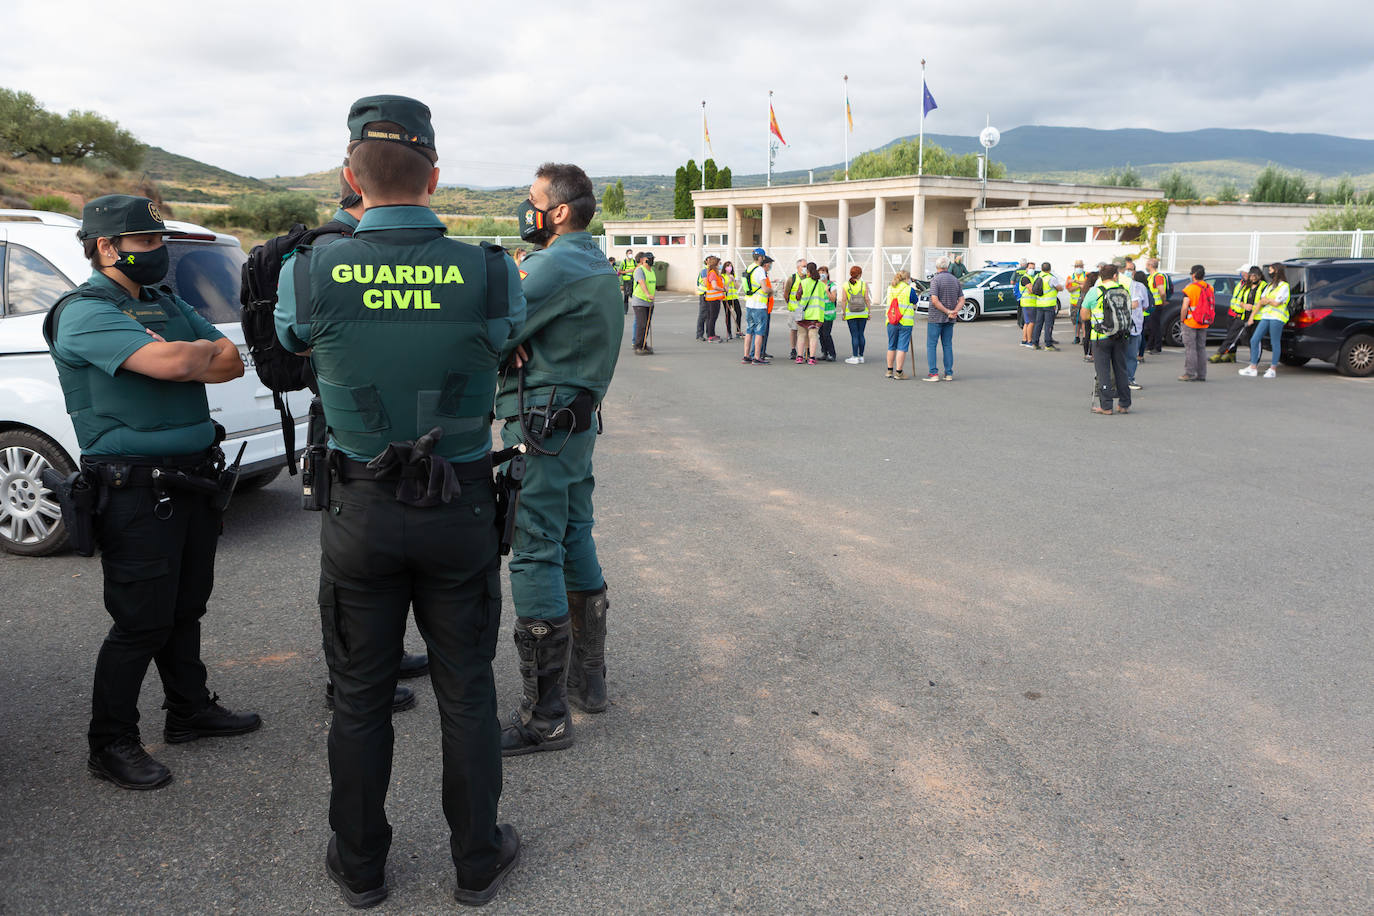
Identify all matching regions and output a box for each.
[51,271,224,456]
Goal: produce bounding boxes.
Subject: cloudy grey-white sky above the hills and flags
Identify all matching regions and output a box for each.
[0,0,1374,185]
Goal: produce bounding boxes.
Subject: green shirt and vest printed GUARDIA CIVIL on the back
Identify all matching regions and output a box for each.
[275,206,525,461]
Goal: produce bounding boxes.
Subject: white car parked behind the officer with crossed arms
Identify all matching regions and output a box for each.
[0,210,309,556]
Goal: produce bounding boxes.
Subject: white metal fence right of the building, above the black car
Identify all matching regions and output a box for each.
[1160,229,1374,273]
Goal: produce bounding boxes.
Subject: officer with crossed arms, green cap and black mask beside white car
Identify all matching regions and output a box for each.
[44,194,262,788]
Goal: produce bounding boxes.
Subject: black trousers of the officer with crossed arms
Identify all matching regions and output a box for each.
[82,456,221,751]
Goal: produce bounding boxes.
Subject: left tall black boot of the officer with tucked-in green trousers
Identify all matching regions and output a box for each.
[502,615,573,757]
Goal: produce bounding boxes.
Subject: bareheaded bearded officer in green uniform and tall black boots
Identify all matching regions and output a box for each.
[496,162,623,757]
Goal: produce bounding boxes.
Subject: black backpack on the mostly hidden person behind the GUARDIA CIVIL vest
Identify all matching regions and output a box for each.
[239,220,353,474]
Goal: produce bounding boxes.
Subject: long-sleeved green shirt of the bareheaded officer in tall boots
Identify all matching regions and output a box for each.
[496,232,625,419]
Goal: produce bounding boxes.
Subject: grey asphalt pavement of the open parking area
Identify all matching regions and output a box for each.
[0,295,1374,913]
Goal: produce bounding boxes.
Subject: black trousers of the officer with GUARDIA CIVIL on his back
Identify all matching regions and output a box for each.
[320,471,502,884]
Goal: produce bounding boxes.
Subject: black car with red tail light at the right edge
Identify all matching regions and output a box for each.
[1269,258,1374,378]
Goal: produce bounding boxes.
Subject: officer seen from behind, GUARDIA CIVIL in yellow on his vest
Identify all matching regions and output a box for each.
[276,96,525,906]
